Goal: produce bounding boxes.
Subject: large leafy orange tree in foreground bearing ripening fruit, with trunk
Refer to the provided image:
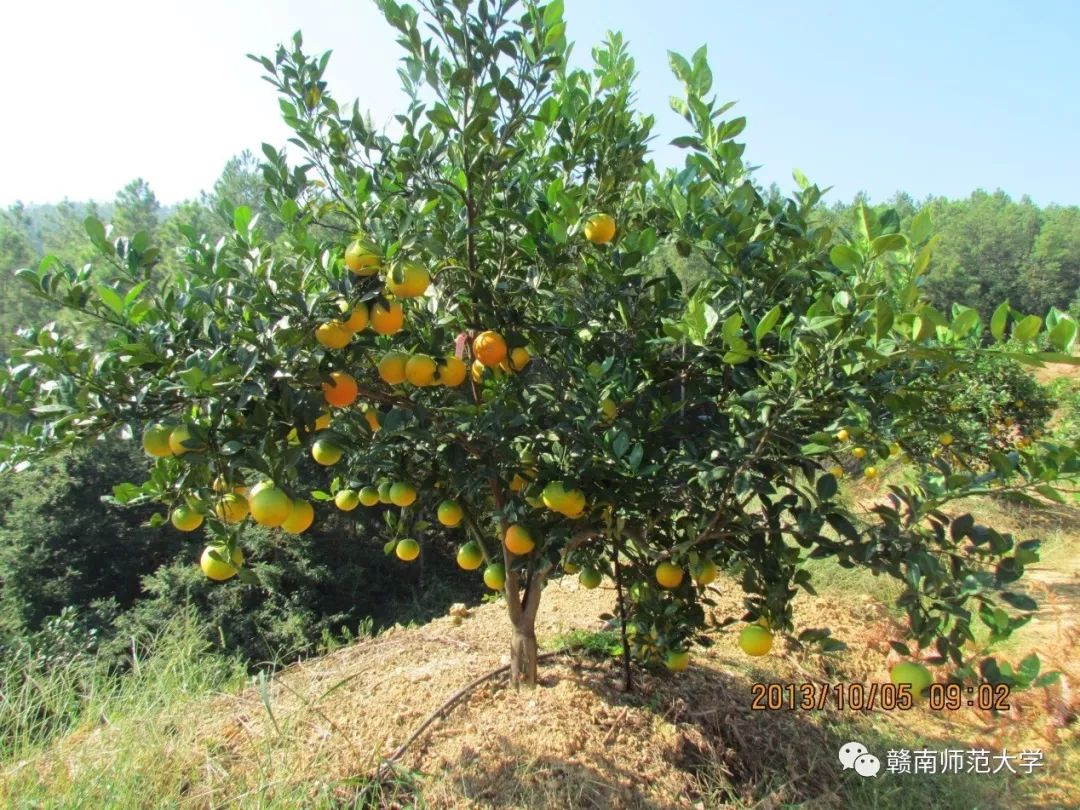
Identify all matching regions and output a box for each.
[3,0,1080,684]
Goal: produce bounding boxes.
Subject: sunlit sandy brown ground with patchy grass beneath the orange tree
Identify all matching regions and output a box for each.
[0,457,1080,808]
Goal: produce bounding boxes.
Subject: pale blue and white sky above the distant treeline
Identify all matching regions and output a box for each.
[0,0,1080,205]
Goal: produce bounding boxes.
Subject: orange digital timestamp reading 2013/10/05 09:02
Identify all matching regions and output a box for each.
[751,683,1011,712]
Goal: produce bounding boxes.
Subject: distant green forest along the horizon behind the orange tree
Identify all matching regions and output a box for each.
[0,151,1080,354]
